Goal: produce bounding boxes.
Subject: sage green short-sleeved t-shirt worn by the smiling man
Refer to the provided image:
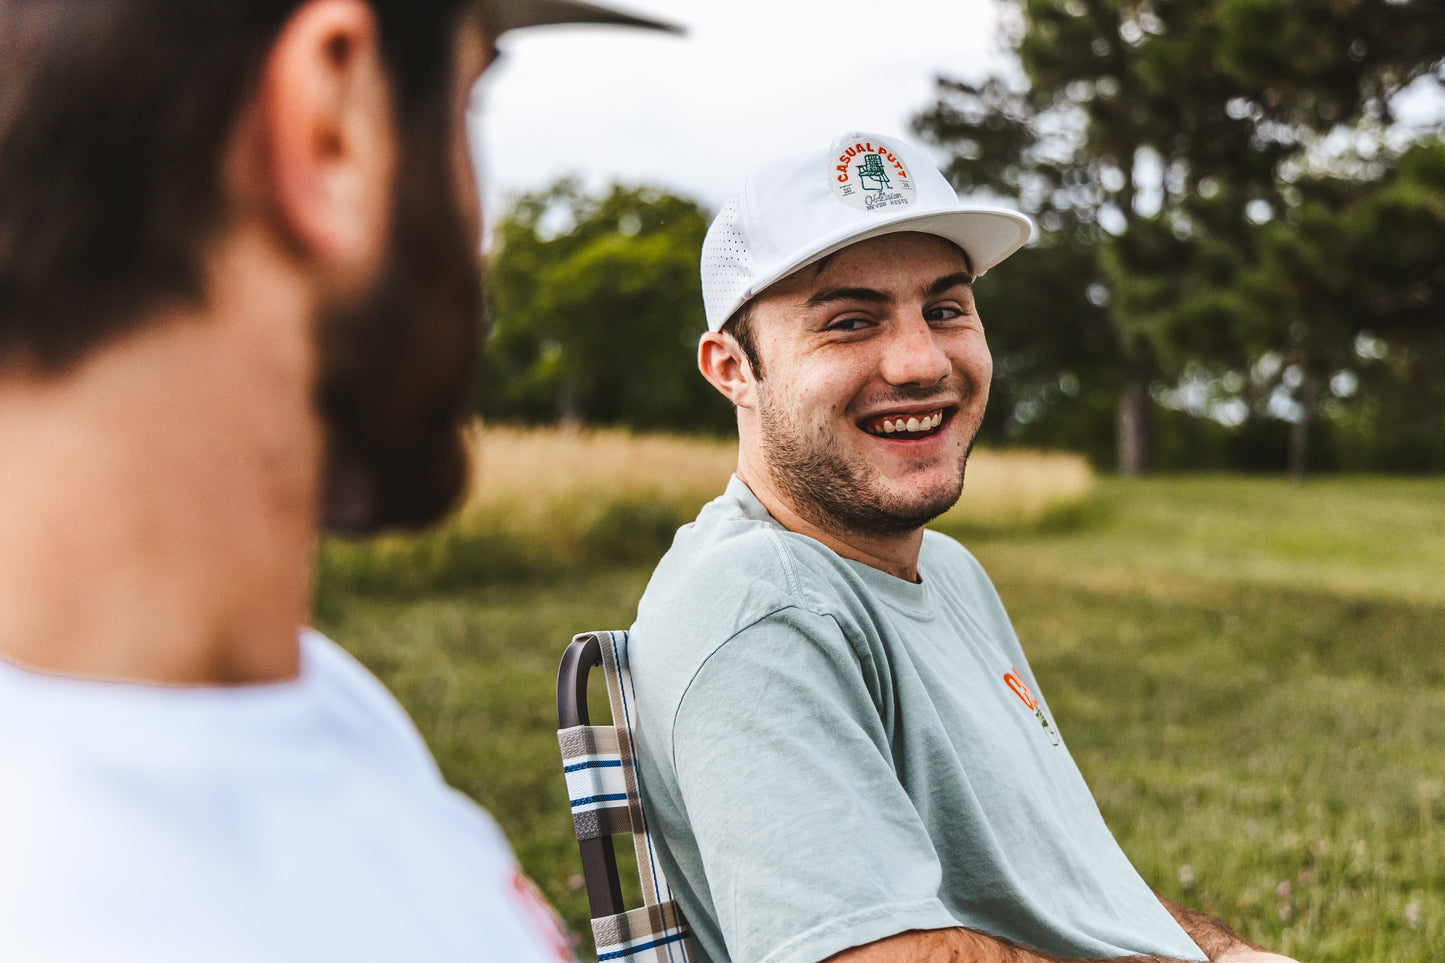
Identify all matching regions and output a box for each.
[629,477,1204,963]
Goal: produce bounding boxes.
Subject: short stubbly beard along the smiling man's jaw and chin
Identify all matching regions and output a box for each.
[759,382,974,536]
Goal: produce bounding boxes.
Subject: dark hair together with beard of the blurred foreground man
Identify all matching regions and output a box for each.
[0,0,481,532]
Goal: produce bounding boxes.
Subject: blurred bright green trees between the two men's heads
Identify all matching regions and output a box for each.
[480,179,733,431]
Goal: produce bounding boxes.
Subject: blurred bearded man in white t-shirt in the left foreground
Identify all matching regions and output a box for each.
[0,0,667,962]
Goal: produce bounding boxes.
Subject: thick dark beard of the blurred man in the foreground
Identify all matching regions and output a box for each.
[316,116,481,534]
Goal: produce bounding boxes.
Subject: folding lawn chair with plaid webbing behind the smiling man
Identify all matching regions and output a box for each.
[556,632,698,963]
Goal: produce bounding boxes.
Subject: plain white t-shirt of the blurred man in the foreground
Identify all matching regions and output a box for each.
[0,632,572,963]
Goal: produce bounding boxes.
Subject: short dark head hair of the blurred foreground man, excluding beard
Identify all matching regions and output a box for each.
[0,0,464,370]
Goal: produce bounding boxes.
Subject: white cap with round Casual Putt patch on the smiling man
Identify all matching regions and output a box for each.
[702,132,1033,331]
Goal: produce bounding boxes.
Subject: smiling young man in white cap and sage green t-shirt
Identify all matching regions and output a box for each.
[630,133,1285,963]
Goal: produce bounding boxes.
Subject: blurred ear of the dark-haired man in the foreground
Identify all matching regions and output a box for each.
[259,0,397,276]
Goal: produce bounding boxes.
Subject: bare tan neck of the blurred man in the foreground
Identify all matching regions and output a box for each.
[0,245,322,684]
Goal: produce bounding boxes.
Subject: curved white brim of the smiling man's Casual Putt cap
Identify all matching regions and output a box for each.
[733,207,1033,311]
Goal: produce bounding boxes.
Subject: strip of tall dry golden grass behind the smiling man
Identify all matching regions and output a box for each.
[321,425,1092,594]
